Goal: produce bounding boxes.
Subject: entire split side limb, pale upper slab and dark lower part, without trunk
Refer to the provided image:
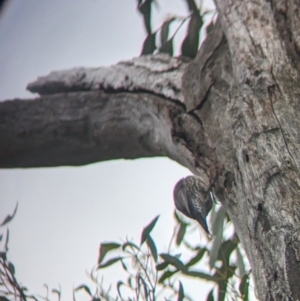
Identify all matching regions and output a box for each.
[0,54,216,188]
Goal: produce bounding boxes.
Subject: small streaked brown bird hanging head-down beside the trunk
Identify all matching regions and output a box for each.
[173,176,213,234]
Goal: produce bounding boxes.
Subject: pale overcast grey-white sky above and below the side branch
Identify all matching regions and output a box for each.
[0,0,217,301]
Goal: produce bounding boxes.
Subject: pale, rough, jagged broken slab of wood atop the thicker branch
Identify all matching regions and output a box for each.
[27,53,187,102]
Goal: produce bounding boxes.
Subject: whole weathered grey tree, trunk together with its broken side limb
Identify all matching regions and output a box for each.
[0,0,300,300]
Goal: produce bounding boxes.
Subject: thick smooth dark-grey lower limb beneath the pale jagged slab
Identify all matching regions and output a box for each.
[0,91,183,168]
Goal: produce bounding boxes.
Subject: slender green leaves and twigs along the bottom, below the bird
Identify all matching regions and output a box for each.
[0,205,250,301]
